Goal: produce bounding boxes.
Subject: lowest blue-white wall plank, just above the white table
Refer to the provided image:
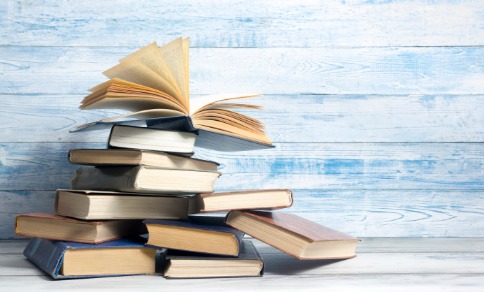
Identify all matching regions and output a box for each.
[0,189,484,239]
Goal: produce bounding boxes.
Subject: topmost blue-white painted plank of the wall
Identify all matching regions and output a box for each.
[0,0,484,48]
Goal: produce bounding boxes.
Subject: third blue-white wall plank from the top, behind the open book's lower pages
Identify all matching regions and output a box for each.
[0,95,484,143]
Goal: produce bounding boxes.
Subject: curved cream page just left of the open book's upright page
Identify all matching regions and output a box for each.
[120,43,184,103]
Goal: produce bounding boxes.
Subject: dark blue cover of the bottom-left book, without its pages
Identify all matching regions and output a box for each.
[23,238,155,279]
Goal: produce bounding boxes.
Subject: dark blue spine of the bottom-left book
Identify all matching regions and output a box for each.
[23,238,67,279]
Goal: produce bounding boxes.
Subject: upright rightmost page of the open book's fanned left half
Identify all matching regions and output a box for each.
[159,38,190,108]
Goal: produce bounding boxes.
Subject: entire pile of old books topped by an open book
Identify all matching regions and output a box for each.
[15,39,357,279]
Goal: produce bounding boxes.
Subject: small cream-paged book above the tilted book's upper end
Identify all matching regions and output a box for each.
[194,189,293,213]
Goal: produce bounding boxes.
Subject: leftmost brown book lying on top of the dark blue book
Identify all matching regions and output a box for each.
[15,213,146,244]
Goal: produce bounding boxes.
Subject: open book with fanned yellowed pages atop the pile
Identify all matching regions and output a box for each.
[75,38,272,148]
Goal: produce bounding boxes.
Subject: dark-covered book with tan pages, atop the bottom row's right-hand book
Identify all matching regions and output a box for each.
[144,217,244,256]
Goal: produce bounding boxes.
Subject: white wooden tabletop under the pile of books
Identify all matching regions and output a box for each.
[0,238,484,292]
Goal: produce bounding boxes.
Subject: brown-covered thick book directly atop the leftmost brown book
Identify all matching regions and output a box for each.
[54,189,193,220]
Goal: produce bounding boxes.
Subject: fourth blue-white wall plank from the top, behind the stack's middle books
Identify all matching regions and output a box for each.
[0,143,484,191]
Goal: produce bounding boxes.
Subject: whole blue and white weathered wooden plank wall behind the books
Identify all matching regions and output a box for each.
[0,0,484,239]
